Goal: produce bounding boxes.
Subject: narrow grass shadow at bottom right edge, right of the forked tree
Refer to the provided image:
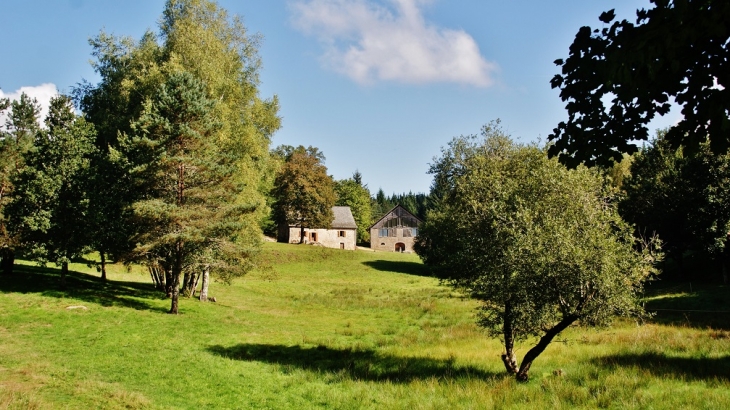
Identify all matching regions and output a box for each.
[593,353,730,382]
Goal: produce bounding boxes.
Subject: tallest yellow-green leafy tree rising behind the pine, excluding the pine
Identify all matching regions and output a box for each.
[76,0,280,302]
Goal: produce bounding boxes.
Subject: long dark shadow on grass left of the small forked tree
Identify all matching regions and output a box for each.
[208,344,498,383]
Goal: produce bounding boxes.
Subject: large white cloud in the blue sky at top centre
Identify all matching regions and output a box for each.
[291,0,498,87]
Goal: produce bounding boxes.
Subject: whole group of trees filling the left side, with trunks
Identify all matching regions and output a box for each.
[0,0,280,313]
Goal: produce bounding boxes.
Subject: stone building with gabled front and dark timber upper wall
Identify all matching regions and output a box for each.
[370,205,423,252]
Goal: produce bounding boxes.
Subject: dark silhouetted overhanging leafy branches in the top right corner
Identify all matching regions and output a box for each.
[548,0,730,167]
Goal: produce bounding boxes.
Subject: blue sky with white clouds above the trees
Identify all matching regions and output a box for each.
[0,0,680,195]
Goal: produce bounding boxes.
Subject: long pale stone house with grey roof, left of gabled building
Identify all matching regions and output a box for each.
[277,206,357,250]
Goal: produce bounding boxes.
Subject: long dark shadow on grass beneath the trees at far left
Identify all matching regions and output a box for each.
[0,265,166,312]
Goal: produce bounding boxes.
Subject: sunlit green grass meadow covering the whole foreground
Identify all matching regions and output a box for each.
[0,244,730,409]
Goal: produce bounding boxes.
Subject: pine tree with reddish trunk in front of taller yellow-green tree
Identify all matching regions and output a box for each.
[122,71,259,314]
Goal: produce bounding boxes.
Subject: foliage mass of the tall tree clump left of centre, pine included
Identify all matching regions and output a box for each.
[75,0,280,302]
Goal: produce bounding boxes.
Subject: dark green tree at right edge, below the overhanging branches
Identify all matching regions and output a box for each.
[619,131,730,276]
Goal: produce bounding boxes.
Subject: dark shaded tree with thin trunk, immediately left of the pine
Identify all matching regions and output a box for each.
[73,32,162,279]
